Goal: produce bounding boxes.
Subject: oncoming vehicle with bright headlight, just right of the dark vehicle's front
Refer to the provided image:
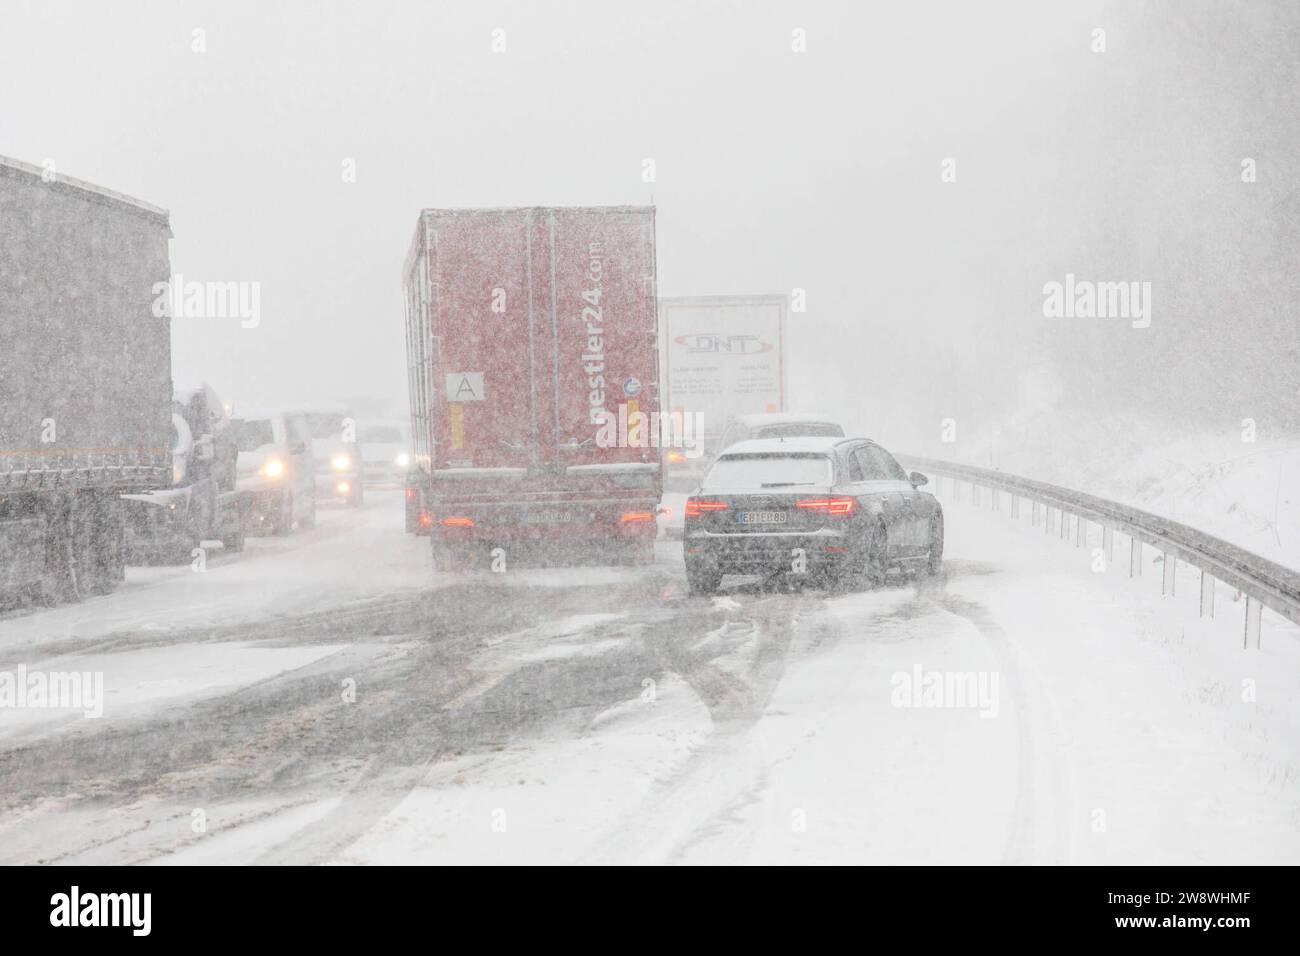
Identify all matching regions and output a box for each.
[230,414,316,535]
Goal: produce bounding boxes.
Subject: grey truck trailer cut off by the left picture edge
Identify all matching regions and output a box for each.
[0,157,172,604]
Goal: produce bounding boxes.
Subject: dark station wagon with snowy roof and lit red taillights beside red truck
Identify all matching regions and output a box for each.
[683,437,944,594]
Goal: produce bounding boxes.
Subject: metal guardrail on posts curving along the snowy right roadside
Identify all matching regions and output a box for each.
[900,455,1300,648]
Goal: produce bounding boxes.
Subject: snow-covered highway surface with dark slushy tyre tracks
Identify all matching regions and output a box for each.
[0,493,1300,864]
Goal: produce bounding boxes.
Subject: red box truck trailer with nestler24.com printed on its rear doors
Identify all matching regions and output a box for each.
[403,207,663,568]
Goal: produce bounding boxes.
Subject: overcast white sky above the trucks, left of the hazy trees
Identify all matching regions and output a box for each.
[0,0,1289,447]
